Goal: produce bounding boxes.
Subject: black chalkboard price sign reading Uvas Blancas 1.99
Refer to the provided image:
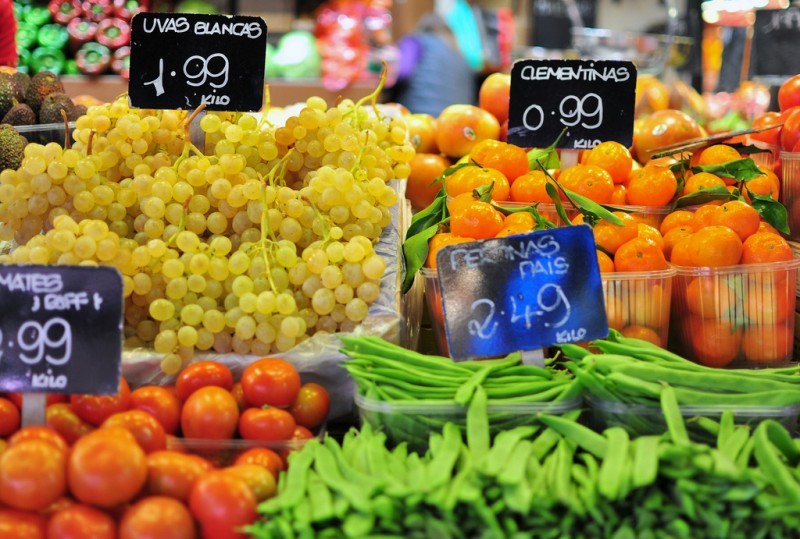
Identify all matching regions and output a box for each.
[128,12,267,111]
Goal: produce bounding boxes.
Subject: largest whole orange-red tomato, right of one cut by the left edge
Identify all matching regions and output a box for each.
[67,427,147,507]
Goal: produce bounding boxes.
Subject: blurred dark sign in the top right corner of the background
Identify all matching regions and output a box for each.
[753,7,800,76]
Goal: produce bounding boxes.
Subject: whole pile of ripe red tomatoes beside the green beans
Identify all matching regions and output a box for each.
[0,358,329,539]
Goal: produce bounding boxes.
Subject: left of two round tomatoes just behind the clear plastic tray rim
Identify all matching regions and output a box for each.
[181,386,239,439]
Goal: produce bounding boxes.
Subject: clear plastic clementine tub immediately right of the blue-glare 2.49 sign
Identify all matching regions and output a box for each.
[600,268,676,346]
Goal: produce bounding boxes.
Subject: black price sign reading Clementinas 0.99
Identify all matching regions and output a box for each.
[508,60,636,150]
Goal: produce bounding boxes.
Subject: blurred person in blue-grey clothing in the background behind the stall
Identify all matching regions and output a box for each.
[394,13,477,117]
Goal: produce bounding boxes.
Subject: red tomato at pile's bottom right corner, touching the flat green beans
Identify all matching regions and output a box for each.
[189,472,258,539]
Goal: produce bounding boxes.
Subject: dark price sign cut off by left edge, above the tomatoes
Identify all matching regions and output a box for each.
[0,265,122,395]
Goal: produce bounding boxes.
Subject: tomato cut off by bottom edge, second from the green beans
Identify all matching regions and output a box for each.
[119,496,197,539]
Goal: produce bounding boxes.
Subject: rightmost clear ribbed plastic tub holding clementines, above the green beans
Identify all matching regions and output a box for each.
[669,258,800,368]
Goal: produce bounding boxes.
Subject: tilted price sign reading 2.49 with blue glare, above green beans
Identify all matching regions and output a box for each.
[436,225,608,360]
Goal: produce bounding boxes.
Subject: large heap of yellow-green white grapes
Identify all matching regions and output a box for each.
[0,89,414,373]
